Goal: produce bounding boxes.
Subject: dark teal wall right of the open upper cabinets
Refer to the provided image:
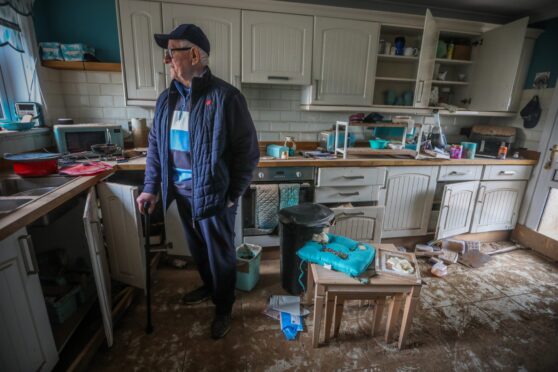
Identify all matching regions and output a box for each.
[525,18,558,89]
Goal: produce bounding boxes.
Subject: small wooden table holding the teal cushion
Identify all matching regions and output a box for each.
[306,244,421,349]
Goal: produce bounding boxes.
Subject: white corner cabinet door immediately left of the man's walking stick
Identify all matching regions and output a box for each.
[97,182,145,289]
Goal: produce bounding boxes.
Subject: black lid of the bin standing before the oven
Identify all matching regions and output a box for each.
[279,203,335,227]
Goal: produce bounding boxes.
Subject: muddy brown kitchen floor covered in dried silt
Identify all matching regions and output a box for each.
[90,246,558,372]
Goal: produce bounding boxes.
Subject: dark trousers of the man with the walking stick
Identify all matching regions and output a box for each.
[175,195,237,314]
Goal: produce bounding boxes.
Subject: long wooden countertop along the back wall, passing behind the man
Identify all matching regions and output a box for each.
[115,156,537,170]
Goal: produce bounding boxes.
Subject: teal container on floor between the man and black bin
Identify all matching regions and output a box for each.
[236,243,262,292]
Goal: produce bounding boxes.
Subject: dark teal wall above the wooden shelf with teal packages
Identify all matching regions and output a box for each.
[33,0,120,62]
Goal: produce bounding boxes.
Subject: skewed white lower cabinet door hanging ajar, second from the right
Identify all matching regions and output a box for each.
[436,181,479,239]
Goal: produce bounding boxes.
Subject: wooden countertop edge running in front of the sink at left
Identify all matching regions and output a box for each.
[0,169,115,240]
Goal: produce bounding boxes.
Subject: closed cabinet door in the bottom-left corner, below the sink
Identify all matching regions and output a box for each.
[0,229,58,371]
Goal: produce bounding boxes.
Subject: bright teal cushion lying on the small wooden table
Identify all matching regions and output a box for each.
[297,234,376,276]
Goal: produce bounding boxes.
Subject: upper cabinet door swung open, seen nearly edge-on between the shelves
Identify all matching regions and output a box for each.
[414,9,438,107]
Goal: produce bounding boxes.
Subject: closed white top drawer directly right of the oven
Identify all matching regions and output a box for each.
[316,167,386,187]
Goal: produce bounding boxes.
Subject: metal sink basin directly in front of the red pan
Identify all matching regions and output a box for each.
[0,176,73,196]
